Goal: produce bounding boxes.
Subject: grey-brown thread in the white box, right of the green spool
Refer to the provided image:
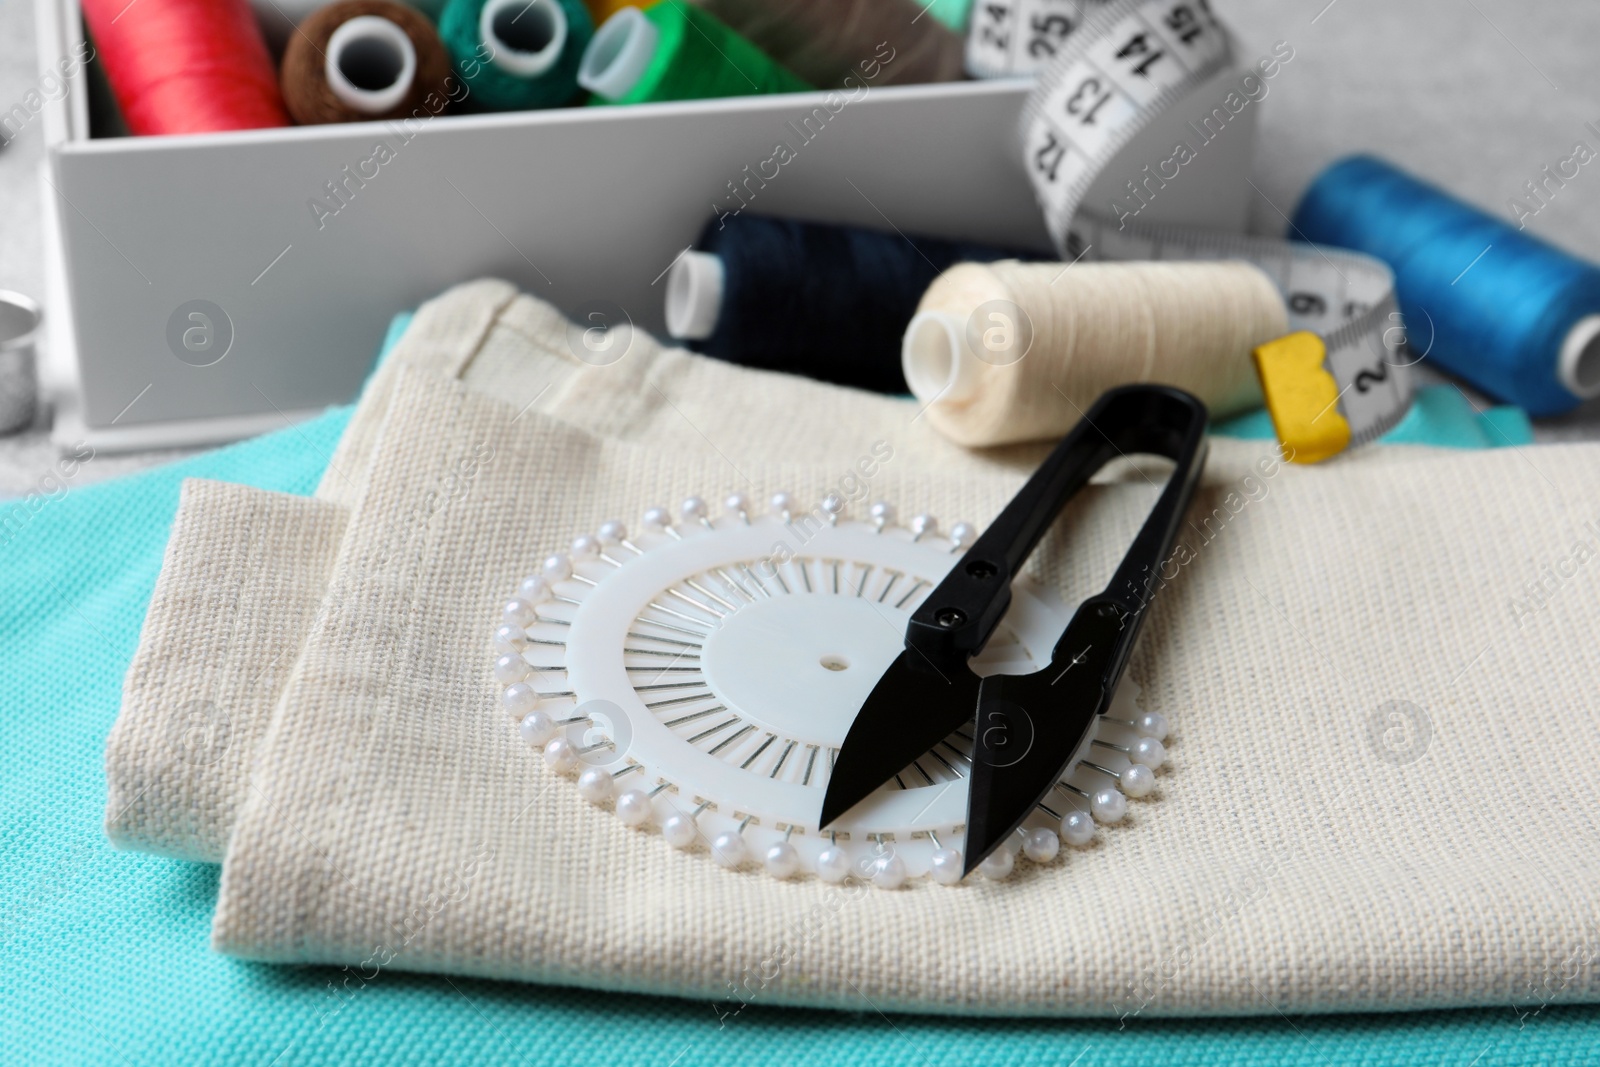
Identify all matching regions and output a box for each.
[694,0,965,88]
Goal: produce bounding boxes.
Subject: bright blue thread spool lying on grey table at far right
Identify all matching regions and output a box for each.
[1294,155,1600,416]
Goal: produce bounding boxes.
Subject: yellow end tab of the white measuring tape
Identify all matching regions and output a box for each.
[1251,330,1350,462]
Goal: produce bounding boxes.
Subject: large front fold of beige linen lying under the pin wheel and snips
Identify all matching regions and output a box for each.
[213,361,1600,1014]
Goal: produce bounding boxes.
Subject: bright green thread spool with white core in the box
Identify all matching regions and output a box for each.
[578,0,813,104]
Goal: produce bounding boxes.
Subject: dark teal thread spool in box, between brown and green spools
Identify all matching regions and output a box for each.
[438,0,594,110]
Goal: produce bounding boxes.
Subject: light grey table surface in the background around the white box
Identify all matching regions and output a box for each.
[0,0,1600,498]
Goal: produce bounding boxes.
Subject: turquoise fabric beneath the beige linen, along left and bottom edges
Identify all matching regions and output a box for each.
[0,351,1600,1067]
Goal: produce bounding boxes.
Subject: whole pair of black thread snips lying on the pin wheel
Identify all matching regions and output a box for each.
[821,386,1206,873]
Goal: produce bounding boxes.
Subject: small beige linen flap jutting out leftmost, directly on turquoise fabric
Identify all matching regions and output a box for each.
[106,478,346,862]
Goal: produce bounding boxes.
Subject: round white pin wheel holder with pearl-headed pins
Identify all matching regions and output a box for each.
[494,493,1168,888]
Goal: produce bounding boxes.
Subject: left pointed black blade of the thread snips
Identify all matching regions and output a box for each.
[821,649,978,829]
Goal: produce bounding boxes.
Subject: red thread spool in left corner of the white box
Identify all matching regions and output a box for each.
[82,0,290,134]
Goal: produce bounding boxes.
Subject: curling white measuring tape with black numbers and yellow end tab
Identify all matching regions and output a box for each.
[966,0,1414,462]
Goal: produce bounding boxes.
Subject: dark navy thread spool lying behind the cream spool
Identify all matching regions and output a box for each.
[666,214,1043,394]
